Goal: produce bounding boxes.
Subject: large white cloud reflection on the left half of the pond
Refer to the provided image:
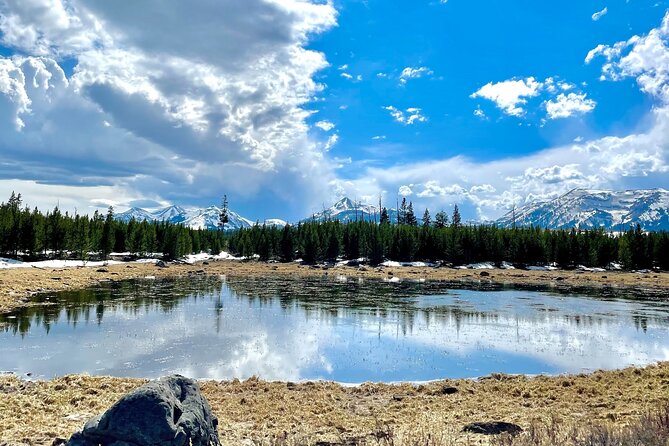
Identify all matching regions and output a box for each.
[0,300,332,380]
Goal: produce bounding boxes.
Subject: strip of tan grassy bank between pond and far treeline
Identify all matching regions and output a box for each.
[0,260,669,313]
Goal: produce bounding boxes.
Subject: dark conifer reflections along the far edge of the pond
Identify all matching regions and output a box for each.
[0,276,669,335]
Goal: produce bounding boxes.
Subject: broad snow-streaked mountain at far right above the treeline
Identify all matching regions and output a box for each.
[497,189,669,231]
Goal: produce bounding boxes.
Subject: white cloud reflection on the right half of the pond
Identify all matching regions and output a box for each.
[364,314,669,372]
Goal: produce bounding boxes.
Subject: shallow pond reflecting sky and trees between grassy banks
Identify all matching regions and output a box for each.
[0,277,669,383]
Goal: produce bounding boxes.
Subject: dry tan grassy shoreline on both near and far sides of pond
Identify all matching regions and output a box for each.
[0,260,669,446]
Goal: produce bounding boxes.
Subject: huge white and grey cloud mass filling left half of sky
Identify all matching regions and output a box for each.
[0,0,337,217]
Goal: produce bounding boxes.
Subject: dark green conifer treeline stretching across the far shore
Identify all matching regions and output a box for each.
[0,193,669,270]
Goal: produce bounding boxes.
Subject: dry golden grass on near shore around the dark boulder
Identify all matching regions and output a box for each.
[0,363,669,446]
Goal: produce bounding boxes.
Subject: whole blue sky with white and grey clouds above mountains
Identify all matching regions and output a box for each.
[0,0,669,221]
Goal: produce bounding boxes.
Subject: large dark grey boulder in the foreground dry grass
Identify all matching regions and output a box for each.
[67,375,221,446]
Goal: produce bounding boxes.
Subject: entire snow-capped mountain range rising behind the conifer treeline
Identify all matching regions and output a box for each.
[116,189,669,231]
